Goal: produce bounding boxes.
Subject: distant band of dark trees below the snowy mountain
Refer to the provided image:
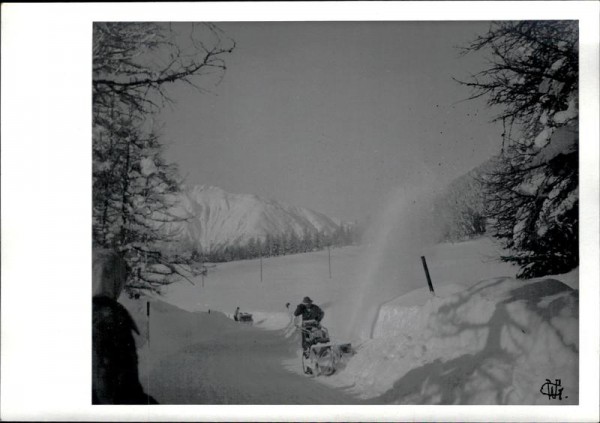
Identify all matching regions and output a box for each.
[192,225,360,263]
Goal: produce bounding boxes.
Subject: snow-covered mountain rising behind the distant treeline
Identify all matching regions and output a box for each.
[171,185,344,251]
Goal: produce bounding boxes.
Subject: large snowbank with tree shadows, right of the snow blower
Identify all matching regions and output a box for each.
[328,278,579,404]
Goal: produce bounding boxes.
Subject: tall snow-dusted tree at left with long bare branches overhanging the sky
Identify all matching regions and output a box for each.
[92,22,234,291]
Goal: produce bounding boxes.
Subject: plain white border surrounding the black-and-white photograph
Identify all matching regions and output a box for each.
[0,1,600,422]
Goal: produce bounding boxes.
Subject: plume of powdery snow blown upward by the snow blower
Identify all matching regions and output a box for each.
[349,184,436,340]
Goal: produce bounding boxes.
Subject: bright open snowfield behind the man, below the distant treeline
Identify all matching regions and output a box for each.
[164,238,516,342]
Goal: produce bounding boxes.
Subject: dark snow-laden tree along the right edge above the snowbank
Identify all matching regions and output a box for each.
[461,21,579,278]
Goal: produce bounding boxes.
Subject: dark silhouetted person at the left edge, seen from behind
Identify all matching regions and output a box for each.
[92,250,157,404]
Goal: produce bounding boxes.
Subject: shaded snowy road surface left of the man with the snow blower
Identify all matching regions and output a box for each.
[121,298,360,405]
